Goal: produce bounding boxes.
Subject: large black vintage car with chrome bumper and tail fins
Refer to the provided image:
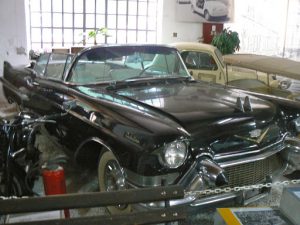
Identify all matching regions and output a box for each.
[1,45,300,211]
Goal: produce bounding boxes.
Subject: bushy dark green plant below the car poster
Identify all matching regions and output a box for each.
[211,28,240,55]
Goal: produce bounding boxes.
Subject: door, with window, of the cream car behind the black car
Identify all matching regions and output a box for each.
[181,51,225,84]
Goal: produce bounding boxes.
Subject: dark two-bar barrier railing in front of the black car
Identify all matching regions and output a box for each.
[0,186,186,225]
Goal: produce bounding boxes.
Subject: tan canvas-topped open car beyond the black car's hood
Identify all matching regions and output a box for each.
[223,54,300,100]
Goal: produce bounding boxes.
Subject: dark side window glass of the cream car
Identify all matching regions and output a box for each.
[181,51,218,70]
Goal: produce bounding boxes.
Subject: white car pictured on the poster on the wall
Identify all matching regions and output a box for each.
[191,0,228,20]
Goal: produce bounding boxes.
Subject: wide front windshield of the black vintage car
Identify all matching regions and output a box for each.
[68,46,190,84]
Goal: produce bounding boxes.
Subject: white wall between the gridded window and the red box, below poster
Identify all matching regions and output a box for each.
[158,0,202,44]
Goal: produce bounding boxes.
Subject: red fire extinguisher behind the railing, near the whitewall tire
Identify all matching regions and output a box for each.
[42,165,70,218]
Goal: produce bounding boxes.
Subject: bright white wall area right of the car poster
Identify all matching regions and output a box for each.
[226,0,290,56]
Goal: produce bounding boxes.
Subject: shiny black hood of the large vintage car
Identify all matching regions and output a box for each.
[116,82,276,138]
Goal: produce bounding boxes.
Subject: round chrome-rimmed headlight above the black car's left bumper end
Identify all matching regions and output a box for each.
[163,141,187,168]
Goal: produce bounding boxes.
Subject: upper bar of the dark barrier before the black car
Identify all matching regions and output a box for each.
[0,185,184,214]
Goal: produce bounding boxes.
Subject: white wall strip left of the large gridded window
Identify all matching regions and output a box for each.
[0,0,29,76]
